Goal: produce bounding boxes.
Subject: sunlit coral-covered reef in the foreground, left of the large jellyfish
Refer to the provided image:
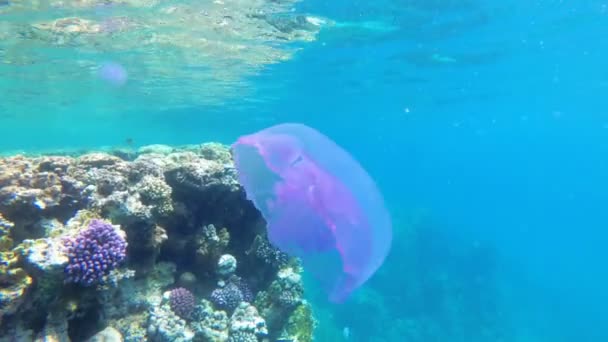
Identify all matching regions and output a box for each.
[0,144,315,342]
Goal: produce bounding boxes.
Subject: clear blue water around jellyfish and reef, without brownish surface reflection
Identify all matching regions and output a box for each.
[0,0,608,342]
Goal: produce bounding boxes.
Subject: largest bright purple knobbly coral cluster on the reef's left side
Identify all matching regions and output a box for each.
[65,219,127,286]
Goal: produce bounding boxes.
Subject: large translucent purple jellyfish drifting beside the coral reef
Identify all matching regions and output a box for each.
[232,123,392,302]
